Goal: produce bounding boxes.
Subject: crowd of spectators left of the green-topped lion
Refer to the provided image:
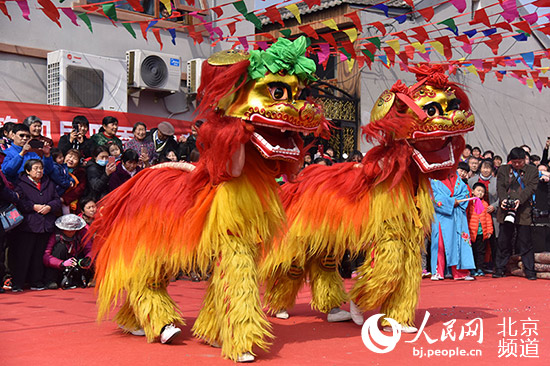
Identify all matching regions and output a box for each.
[0,116,201,292]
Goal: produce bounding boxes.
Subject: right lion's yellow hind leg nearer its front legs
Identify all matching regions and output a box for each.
[308,256,347,313]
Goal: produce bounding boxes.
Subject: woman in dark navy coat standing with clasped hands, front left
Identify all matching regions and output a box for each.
[8,159,61,292]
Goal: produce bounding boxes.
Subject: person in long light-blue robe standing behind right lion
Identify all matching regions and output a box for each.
[430,174,475,281]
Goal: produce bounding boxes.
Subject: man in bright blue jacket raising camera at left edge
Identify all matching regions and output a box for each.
[2,124,53,185]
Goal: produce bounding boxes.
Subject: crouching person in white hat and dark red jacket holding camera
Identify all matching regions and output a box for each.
[43,214,92,290]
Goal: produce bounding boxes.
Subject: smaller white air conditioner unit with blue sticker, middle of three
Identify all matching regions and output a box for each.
[126,50,181,93]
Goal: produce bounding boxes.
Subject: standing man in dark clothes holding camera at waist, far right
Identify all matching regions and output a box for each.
[493,147,539,280]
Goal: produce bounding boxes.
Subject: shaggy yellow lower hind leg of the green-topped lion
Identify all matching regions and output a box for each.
[119,278,184,342]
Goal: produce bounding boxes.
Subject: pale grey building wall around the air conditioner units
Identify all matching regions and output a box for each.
[0,0,216,120]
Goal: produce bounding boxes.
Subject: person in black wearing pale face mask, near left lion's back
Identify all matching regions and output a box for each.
[84,146,116,201]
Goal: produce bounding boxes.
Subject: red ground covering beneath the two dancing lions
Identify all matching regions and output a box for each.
[0,277,550,366]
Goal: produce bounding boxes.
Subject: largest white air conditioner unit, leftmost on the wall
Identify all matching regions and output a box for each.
[47,50,128,112]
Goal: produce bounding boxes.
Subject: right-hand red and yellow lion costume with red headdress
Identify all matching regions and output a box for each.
[262,66,474,332]
